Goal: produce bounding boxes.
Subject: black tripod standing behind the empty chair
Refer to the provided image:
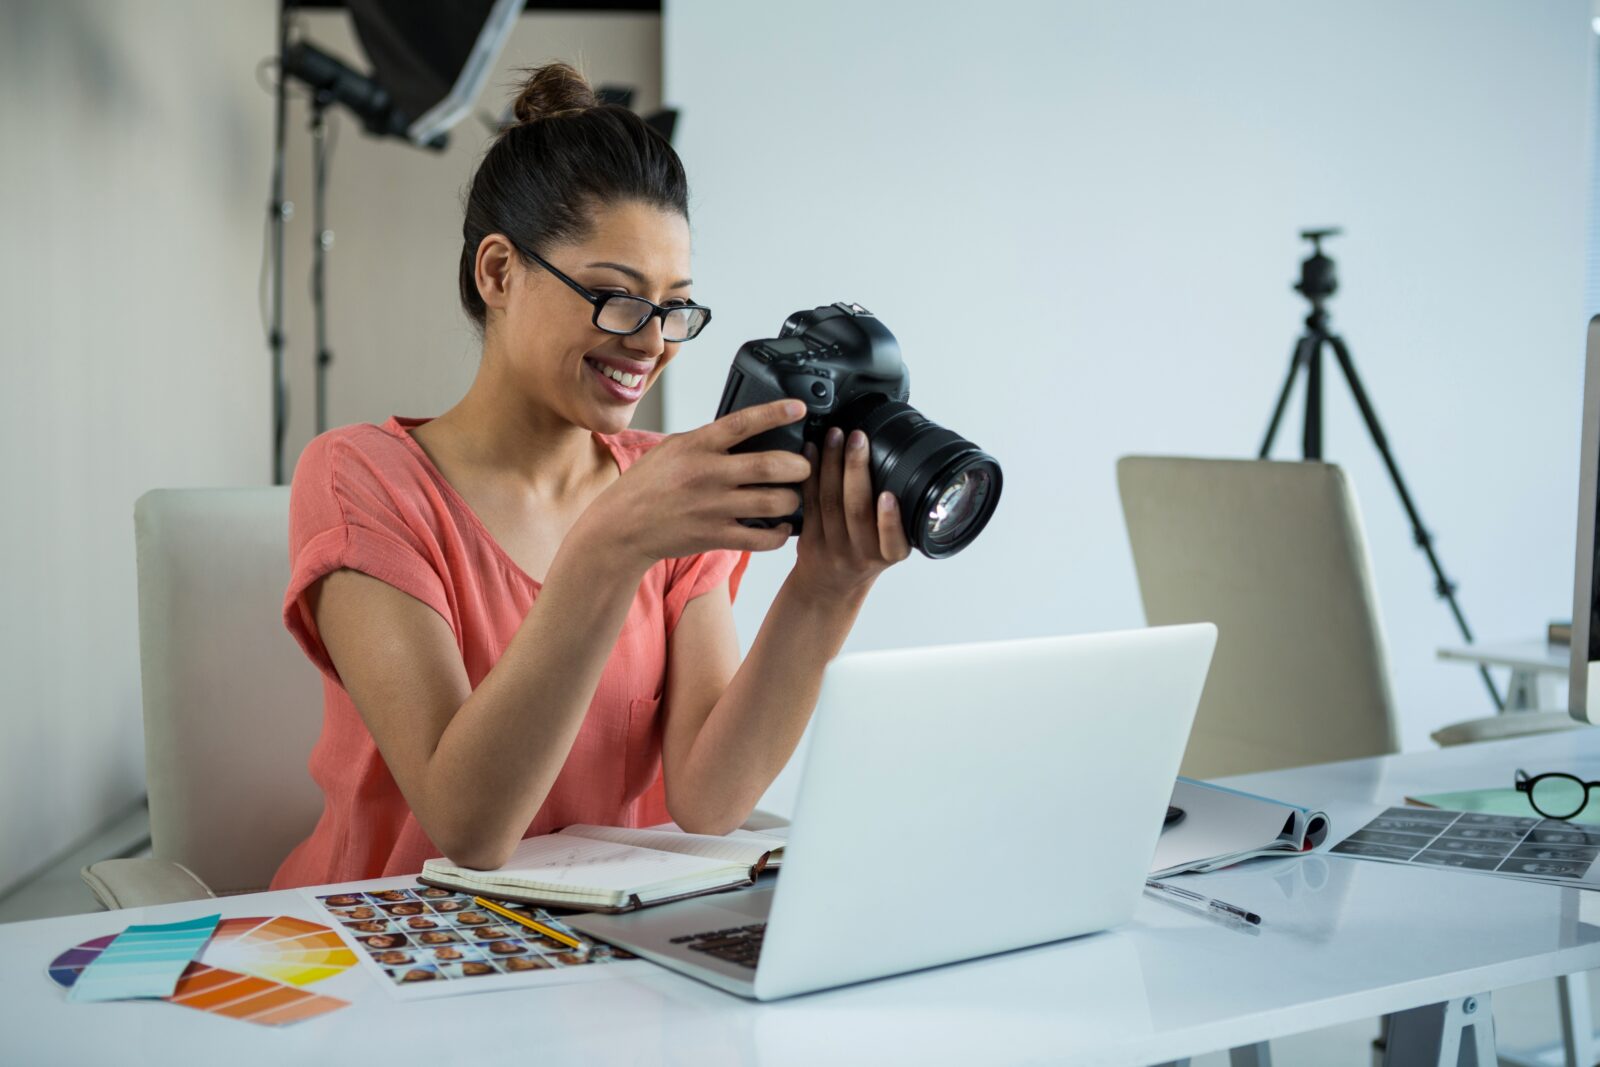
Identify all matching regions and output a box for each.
[1259,227,1506,710]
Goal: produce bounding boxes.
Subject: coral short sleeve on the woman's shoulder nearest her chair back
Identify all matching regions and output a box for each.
[283,430,456,685]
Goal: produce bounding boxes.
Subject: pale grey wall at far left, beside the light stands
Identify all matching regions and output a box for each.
[0,0,274,891]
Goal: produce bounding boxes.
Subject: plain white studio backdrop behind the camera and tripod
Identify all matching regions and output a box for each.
[664,0,1594,808]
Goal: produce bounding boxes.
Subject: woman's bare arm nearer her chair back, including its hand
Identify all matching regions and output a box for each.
[307,396,806,867]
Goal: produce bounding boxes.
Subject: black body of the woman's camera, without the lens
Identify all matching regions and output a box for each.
[717,302,910,460]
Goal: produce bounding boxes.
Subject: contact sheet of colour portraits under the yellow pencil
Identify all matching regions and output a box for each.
[306,883,646,998]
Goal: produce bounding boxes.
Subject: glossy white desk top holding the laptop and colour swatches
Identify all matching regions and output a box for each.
[0,729,1600,1067]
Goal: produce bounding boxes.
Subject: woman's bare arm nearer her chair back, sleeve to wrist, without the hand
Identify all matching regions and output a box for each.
[312,530,648,867]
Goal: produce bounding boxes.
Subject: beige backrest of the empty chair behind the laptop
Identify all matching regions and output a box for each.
[1117,456,1397,777]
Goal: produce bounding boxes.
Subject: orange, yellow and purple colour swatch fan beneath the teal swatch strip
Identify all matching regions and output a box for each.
[50,915,355,1025]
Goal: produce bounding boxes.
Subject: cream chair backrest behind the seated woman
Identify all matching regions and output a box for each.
[133,488,322,893]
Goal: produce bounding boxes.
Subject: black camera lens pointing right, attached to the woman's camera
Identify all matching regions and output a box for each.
[843,395,1000,560]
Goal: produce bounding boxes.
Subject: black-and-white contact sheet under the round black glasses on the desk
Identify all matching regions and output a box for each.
[1330,808,1600,889]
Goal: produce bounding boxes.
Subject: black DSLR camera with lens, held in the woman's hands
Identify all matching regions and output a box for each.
[717,304,1000,560]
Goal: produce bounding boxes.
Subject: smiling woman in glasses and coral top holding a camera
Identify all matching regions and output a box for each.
[272,64,910,888]
